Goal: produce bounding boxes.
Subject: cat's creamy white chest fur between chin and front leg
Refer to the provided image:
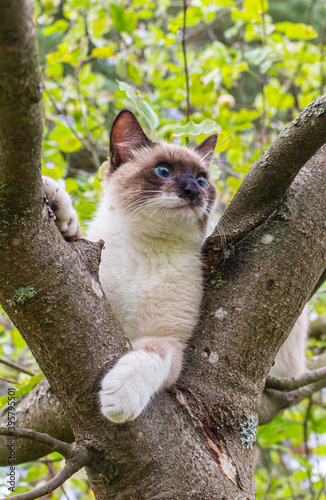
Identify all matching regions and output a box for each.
[87,199,202,342]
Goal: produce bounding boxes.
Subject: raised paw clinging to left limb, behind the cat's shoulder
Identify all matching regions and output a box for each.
[43,176,79,238]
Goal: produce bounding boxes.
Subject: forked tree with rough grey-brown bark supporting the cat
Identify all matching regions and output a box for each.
[0,0,326,499]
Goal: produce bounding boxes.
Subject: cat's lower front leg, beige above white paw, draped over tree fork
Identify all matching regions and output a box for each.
[100,337,185,422]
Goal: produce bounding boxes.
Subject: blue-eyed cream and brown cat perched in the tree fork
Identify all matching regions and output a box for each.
[44,110,304,422]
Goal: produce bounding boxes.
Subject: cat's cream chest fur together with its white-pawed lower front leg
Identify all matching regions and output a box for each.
[87,150,205,422]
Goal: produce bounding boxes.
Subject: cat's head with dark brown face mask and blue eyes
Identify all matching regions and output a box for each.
[107,110,217,230]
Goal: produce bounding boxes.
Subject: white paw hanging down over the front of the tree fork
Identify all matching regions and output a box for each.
[99,351,169,422]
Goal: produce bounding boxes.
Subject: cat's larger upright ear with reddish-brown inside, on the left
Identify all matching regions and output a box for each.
[110,109,154,171]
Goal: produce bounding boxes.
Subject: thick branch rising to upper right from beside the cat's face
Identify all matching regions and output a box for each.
[206,95,326,250]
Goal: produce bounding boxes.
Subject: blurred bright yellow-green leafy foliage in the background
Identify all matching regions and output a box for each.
[0,0,326,500]
